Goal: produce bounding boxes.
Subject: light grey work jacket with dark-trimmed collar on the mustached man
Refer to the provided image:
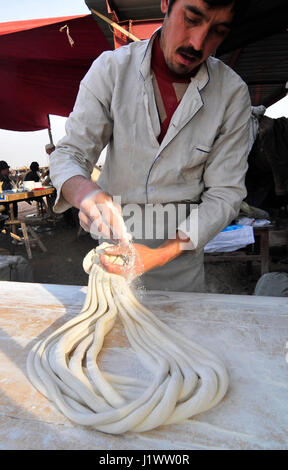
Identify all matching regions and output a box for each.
[50,28,251,255]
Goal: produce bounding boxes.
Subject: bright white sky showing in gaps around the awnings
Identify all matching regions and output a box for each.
[0,0,288,168]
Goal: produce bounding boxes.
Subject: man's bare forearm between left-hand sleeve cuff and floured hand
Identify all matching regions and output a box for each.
[62,175,101,209]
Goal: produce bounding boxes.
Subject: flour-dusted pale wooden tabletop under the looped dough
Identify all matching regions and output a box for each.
[0,281,288,450]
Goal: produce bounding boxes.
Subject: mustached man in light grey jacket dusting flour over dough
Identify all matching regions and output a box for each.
[50,0,251,291]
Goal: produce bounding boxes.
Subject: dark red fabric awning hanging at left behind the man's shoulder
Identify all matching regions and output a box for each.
[0,15,111,131]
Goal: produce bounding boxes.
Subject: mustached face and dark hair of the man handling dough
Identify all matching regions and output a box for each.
[160,0,234,76]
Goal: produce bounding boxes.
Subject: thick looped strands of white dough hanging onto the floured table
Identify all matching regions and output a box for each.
[27,243,229,434]
